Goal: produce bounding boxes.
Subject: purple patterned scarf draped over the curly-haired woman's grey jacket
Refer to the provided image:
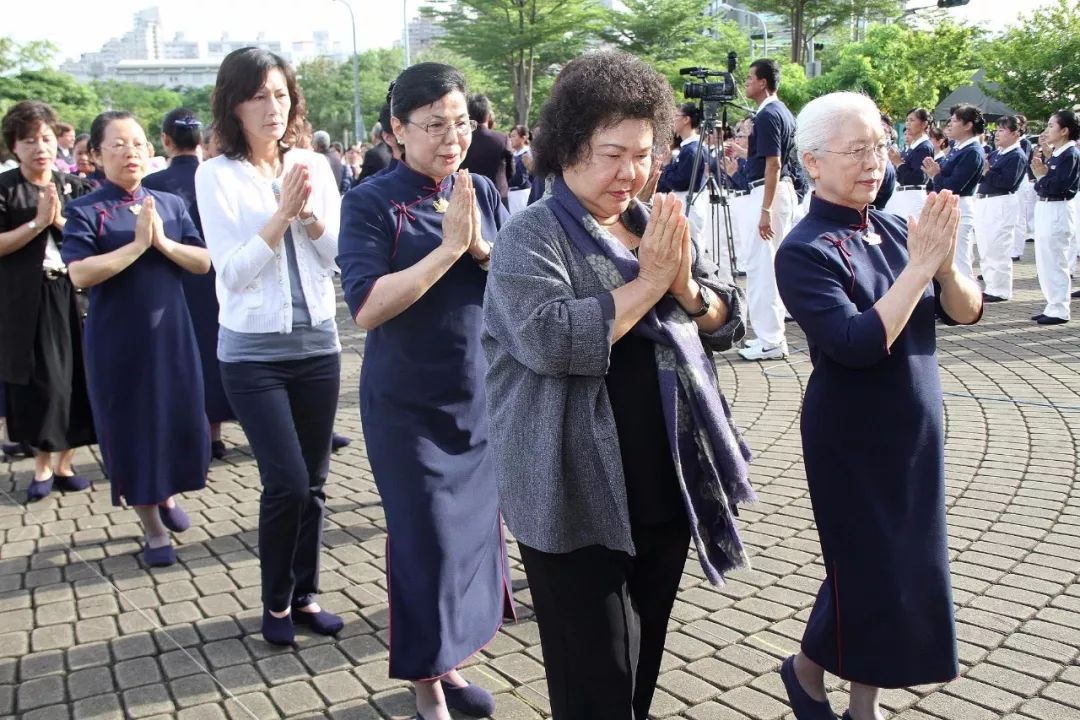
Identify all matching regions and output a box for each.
[548,177,756,585]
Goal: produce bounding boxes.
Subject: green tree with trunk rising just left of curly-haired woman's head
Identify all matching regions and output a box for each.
[421,0,604,123]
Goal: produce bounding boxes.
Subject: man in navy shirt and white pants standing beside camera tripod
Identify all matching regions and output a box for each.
[739,59,798,361]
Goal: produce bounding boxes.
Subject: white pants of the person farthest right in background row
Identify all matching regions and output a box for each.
[1035,200,1077,320]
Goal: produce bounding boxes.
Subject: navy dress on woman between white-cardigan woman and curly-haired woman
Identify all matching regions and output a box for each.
[337,163,511,680]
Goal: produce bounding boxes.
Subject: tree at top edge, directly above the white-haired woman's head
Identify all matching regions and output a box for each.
[748,0,901,65]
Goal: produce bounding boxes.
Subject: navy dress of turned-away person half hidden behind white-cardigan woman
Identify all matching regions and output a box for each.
[143,155,237,422]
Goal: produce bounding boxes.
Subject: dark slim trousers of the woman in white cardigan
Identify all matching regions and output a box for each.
[220,353,341,611]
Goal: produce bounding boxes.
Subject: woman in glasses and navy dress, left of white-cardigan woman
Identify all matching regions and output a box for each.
[60,111,210,567]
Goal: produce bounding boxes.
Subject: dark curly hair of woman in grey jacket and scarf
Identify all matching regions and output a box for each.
[532,50,675,175]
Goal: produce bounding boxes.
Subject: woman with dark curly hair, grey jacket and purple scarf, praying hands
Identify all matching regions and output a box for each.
[484,52,754,720]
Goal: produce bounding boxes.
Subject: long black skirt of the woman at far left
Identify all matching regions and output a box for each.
[4,275,97,452]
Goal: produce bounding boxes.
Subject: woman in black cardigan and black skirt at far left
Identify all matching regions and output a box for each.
[0,100,95,500]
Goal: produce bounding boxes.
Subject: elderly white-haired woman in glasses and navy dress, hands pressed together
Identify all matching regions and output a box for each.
[775,93,982,720]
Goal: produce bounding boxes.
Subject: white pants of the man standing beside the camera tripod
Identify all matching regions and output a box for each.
[739,181,798,347]
